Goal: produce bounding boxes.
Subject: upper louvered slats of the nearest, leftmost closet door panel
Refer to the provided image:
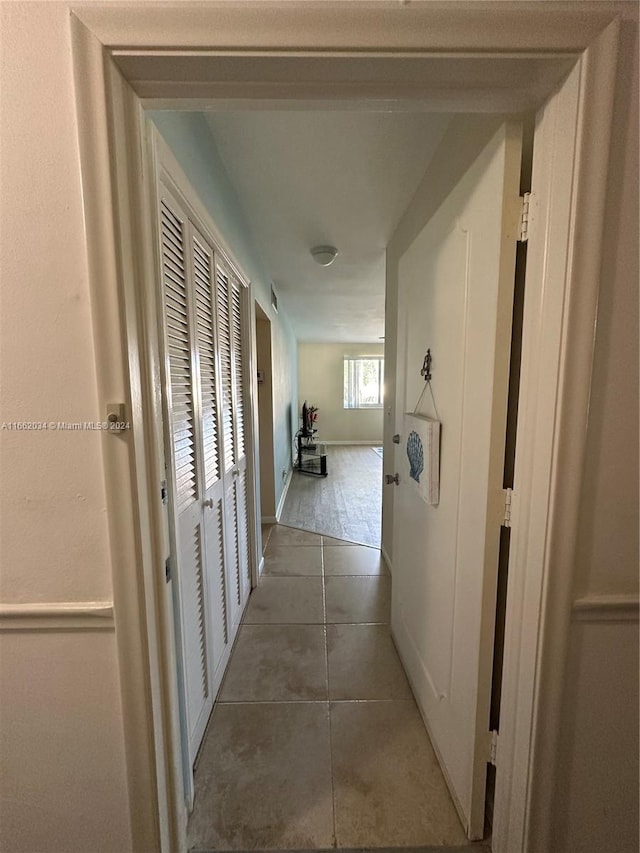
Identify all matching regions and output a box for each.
[160,199,197,515]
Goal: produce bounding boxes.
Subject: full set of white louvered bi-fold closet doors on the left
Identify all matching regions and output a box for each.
[159,184,250,761]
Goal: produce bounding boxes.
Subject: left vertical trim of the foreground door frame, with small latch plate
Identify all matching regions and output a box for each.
[70,20,166,851]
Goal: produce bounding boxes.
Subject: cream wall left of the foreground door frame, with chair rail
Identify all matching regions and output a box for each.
[0,3,132,853]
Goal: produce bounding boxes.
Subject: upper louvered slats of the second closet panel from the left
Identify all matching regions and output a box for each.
[193,236,220,489]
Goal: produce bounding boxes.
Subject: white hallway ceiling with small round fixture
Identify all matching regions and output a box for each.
[207,110,451,343]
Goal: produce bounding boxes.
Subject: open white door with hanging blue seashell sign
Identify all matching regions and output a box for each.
[392,123,521,839]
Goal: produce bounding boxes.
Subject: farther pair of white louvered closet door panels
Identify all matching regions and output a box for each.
[216,258,251,626]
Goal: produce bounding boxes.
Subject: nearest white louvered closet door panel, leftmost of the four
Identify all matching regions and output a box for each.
[160,187,215,762]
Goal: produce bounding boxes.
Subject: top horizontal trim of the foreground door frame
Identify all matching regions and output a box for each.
[75,5,628,53]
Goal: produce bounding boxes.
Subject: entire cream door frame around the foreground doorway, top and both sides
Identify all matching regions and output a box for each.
[71,0,619,853]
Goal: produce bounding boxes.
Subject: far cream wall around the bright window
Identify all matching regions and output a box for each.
[298,343,384,444]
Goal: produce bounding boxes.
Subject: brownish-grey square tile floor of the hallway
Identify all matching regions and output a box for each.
[188,524,468,851]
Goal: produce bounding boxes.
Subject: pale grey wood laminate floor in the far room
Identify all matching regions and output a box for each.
[280,445,382,548]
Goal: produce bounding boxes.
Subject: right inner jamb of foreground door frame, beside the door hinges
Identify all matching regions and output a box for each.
[493,65,580,853]
